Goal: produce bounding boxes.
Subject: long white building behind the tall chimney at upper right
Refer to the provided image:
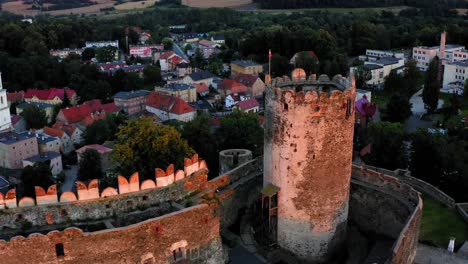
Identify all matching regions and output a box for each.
[413,44,468,71]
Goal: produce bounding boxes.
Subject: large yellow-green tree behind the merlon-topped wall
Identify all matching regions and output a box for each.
[113,117,194,179]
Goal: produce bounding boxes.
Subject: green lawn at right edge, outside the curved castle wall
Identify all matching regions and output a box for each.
[419,196,468,248]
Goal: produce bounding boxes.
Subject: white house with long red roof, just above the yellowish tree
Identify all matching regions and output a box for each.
[146,92,197,122]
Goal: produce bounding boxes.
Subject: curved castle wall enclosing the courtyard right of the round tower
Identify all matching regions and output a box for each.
[349,165,423,264]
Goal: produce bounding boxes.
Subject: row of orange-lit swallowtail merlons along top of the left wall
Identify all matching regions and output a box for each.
[0,154,208,209]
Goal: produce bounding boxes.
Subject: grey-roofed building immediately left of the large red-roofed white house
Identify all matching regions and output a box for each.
[114,90,150,115]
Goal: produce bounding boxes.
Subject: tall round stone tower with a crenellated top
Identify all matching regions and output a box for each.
[262,69,356,263]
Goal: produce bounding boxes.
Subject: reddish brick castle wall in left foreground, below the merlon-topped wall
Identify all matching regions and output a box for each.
[0,205,224,264]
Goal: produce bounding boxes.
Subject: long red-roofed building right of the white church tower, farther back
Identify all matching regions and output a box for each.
[24,88,78,105]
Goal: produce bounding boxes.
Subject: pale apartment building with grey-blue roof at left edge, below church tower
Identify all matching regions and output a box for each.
[0,131,39,169]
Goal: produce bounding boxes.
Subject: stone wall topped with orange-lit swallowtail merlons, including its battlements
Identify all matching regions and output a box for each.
[0,156,208,228]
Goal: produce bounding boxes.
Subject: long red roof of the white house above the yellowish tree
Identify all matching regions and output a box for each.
[146,92,195,115]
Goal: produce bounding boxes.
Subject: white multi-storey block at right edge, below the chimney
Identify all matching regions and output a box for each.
[442,60,468,94]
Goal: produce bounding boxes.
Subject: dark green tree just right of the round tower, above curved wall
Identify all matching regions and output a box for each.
[364,122,407,170]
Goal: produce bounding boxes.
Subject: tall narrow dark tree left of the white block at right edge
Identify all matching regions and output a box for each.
[422,57,440,113]
